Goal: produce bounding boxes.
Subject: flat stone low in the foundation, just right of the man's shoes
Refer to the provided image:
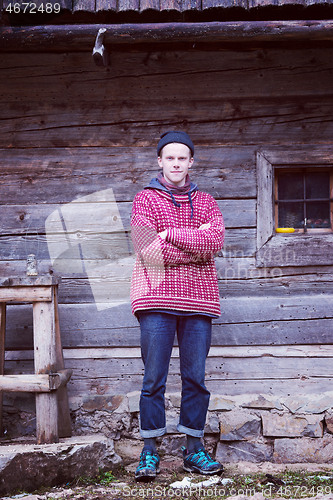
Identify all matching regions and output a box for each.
[215,440,273,463]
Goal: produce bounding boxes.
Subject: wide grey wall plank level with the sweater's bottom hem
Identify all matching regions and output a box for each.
[6,296,333,349]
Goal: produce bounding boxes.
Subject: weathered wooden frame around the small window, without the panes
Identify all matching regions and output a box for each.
[256,145,333,267]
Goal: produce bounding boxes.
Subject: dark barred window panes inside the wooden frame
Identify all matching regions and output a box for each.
[275,168,332,233]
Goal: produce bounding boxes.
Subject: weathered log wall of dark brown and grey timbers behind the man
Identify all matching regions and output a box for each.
[0,44,333,418]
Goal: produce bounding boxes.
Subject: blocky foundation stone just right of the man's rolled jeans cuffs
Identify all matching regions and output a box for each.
[220,410,261,441]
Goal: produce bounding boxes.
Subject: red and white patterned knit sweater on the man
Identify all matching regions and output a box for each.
[131,189,225,316]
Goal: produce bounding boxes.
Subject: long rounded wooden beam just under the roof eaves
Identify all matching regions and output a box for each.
[0,21,332,52]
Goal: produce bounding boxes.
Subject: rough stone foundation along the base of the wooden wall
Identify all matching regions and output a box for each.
[7,392,333,463]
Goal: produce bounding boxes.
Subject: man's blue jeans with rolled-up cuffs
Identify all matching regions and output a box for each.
[138,311,211,438]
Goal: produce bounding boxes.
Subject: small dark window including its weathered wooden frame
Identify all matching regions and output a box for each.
[256,149,333,267]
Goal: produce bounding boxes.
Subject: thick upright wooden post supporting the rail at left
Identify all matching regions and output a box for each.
[33,296,59,444]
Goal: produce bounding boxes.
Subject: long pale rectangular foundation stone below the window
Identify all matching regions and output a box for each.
[261,413,324,438]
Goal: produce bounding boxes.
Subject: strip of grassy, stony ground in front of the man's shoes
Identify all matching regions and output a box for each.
[4,468,333,500]
